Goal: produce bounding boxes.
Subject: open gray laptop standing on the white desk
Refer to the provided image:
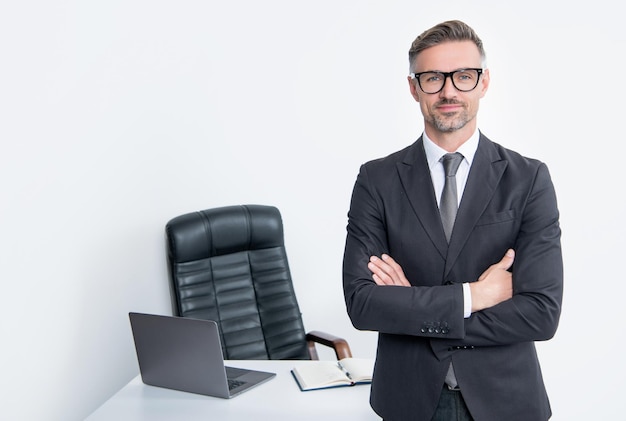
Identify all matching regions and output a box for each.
[129,312,276,398]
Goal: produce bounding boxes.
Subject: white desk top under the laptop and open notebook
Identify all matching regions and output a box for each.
[87,361,380,421]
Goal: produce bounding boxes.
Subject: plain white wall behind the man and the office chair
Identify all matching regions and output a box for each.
[0,0,626,421]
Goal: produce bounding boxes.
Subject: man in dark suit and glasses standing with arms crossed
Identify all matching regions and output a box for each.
[343,21,563,421]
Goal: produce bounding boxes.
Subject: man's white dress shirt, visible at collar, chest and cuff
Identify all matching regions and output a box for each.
[422,129,480,318]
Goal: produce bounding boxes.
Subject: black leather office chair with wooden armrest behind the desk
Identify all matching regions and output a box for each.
[165,205,352,360]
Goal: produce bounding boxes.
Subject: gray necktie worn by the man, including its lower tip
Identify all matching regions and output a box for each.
[439,152,463,389]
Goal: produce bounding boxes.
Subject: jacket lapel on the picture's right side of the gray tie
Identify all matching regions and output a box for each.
[445,134,508,275]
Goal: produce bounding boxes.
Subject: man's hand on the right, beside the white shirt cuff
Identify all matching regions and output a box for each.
[469,249,515,313]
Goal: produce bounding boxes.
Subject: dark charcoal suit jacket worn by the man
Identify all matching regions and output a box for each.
[343,134,563,421]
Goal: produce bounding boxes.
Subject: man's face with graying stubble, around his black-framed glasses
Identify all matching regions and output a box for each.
[409,41,489,133]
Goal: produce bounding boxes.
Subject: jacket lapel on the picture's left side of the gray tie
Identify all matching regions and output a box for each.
[397,137,448,258]
